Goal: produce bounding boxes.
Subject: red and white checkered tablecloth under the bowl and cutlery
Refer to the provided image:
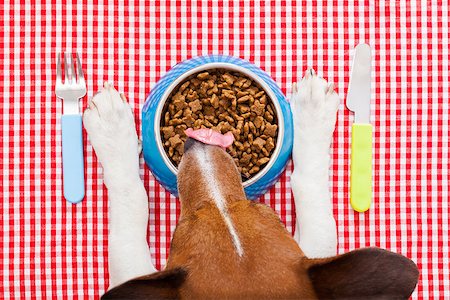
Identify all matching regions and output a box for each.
[0,0,450,299]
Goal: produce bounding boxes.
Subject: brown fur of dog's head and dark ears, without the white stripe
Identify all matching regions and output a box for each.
[103,144,418,299]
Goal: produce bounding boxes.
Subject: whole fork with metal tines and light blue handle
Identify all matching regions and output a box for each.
[55,53,86,203]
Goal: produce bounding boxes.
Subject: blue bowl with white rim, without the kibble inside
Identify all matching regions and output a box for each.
[142,55,293,199]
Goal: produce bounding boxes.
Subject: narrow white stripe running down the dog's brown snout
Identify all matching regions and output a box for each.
[193,147,244,257]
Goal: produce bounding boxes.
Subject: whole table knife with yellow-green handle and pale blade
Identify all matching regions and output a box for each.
[346,44,372,212]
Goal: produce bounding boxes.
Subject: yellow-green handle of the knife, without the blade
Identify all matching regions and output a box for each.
[350,123,372,212]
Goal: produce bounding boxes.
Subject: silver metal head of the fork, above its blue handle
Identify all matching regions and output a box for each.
[55,53,86,114]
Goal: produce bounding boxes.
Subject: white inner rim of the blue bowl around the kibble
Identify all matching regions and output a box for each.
[154,62,284,188]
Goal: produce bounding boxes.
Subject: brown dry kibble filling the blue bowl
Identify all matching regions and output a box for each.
[161,69,278,180]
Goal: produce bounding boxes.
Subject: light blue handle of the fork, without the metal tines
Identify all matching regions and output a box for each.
[61,115,84,203]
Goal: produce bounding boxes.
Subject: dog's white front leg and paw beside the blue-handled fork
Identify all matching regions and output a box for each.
[83,83,156,289]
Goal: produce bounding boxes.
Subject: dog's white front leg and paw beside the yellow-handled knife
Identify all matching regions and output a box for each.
[291,69,339,258]
